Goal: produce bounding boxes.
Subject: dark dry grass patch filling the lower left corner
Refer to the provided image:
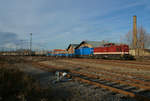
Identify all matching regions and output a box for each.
[0,57,66,101]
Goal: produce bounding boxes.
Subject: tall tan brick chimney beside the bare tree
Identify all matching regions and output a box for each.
[133,16,137,49]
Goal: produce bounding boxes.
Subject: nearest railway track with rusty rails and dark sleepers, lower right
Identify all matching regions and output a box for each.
[68,71,150,101]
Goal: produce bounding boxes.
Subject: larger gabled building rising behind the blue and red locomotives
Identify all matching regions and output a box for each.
[76,41,108,49]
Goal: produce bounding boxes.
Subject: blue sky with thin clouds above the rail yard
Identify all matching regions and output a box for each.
[0,0,150,50]
